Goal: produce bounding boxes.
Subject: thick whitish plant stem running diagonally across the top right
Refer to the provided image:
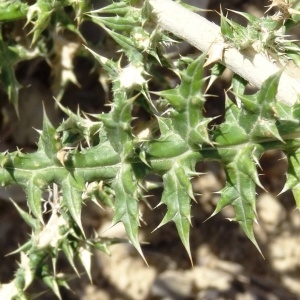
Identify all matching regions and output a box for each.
[149,0,300,106]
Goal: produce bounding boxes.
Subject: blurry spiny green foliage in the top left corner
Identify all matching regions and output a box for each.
[0,0,89,112]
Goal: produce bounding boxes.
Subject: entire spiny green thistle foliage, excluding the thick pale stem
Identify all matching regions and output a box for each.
[0,0,300,299]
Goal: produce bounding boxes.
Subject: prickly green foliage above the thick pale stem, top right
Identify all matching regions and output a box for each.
[221,0,299,65]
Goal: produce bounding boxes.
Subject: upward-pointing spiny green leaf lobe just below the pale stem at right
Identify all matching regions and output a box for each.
[223,71,286,144]
